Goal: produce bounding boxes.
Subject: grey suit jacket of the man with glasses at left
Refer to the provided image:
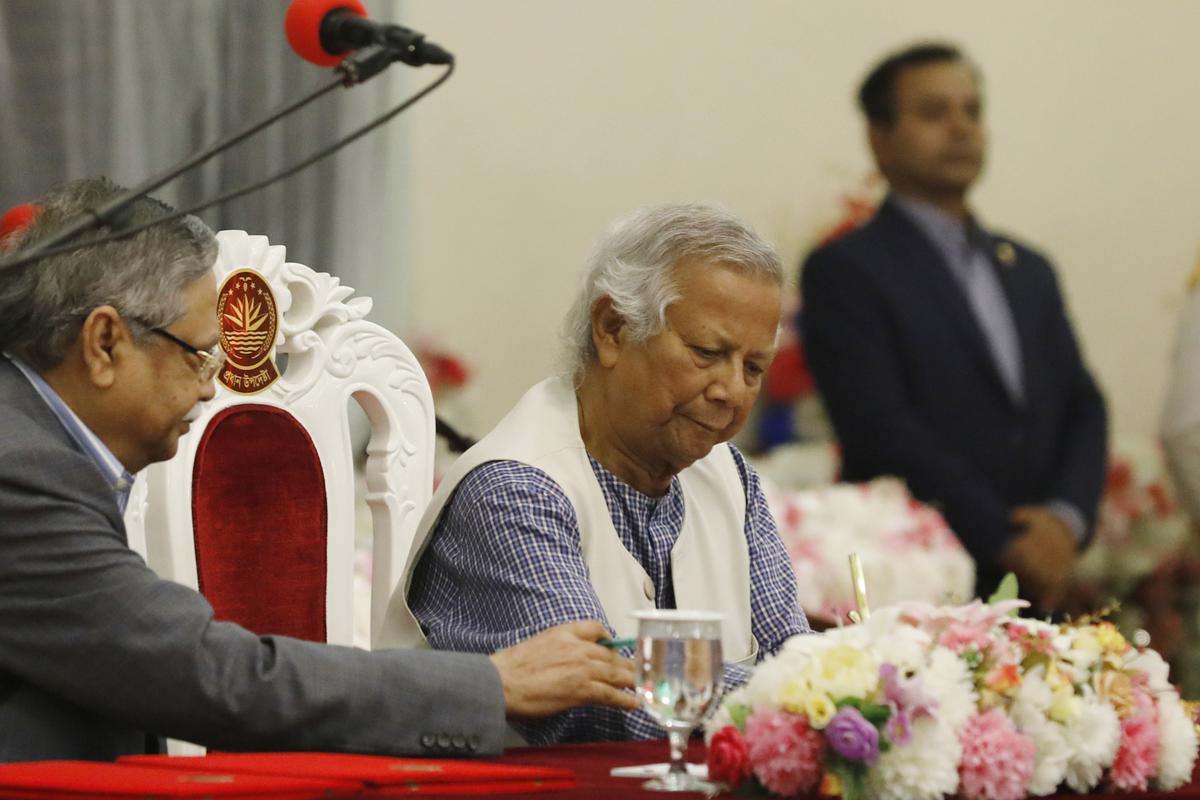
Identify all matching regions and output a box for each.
[0,359,505,762]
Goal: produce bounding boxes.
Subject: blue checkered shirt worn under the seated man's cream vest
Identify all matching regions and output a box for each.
[408,447,810,745]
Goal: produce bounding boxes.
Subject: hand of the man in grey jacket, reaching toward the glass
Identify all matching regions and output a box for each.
[491,620,638,717]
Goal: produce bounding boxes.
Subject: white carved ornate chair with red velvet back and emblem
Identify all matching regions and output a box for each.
[126,230,434,644]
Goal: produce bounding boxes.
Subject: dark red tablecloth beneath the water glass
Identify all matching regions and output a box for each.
[465,740,1200,800]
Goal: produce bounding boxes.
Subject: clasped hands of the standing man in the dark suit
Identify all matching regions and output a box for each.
[1001,506,1079,612]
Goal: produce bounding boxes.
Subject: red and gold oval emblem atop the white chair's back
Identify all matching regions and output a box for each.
[217,269,280,395]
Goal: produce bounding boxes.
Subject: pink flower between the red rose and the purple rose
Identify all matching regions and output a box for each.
[745,708,824,798]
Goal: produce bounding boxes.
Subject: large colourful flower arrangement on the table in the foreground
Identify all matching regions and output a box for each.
[708,591,1196,800]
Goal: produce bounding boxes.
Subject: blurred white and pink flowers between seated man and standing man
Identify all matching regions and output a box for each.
[763,479,974,624]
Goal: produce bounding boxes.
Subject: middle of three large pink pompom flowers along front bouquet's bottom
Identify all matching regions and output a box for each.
[959,709,1034,800]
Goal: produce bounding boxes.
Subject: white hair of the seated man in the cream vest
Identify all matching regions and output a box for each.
[563,205,784,381]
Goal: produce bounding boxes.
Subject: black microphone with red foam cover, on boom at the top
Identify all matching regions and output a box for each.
[283,0,454,67]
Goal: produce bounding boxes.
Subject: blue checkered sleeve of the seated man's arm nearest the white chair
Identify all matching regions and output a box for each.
[409,461,662,745]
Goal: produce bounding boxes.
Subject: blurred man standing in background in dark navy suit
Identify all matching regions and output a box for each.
[802,44,1108,610]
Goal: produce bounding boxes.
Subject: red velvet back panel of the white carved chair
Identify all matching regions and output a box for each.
[192,403,329,642]
